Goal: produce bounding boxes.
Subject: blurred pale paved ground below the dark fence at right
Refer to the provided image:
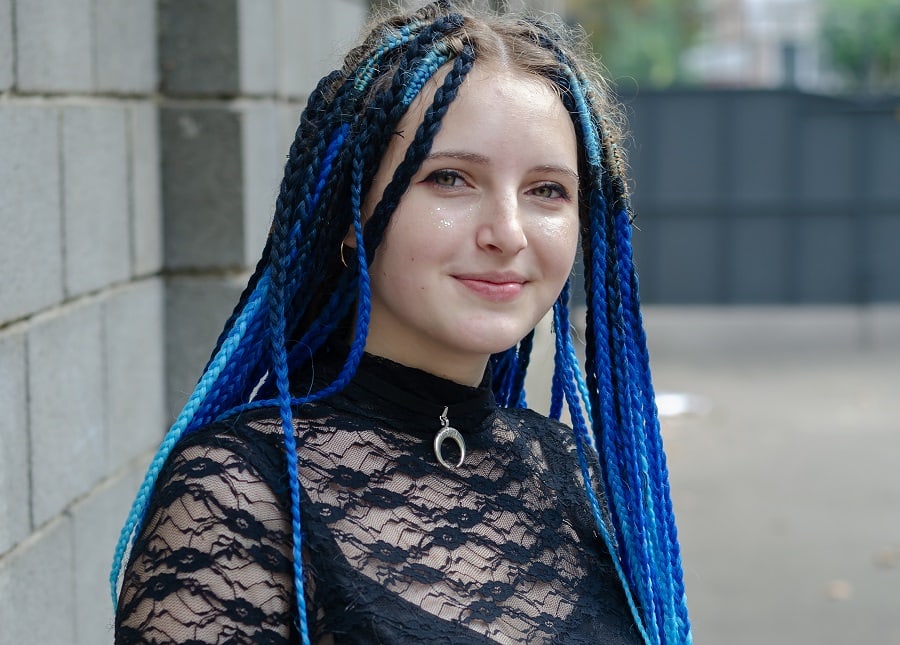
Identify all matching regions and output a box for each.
[532,309,900,645]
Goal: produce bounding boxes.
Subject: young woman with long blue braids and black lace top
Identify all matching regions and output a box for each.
[112,2,691,644]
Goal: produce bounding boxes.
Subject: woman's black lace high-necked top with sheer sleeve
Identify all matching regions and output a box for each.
[116,356,641,645]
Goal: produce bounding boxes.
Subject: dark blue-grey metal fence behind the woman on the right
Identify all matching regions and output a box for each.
[626,90,900,304]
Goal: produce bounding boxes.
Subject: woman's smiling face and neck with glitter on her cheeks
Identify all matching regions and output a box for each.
[364,64,578,384]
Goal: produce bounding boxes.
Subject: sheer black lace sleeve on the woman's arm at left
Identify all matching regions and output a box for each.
[116,438,293,643]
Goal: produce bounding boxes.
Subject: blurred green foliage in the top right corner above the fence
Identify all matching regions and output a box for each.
[821,0,900,91]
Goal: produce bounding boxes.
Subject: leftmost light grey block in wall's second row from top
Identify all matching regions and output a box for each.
[0,102,62,321]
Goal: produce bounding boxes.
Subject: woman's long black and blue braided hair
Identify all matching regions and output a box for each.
[110,0,692,645]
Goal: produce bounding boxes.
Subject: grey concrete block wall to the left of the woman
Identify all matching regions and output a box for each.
[0,0,367,645]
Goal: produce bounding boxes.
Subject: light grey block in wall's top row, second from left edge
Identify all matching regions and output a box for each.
[15,0,94,92]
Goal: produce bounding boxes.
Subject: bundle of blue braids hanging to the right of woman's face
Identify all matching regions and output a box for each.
[552,46,691,644]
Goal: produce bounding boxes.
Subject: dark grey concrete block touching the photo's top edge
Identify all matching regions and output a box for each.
[158,0,240,96]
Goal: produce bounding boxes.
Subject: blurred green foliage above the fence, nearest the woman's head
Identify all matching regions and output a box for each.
[567,0,700,87]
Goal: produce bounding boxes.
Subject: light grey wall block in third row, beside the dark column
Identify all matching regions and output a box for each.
[103,278,168,473]
